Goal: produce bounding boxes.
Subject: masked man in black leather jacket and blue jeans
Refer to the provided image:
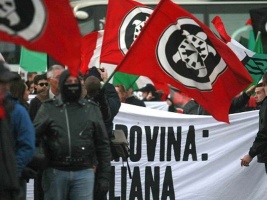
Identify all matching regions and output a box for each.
[34,70,110,200]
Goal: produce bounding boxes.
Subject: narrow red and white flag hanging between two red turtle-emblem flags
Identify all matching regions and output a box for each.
[81,30,104,74]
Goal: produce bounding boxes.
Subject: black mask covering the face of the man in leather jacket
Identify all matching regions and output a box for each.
[61,84,82,102]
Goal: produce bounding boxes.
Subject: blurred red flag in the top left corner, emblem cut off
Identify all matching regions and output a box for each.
[0,0,81,75]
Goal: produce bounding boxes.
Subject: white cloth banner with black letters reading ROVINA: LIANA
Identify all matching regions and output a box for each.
[109,104,267,200]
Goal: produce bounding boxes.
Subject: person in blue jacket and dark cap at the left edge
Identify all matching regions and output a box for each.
[0,61,35,199]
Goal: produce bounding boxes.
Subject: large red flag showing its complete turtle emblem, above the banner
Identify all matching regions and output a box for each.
[117,0,252,122]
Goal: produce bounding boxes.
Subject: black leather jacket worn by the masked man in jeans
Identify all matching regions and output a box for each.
[34,98,110,180]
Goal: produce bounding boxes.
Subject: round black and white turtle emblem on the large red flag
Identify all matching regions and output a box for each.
[157,18,226,90]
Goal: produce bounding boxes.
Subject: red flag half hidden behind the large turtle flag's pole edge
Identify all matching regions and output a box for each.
[100,0,153,65]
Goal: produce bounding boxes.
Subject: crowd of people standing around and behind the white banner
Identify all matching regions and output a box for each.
[0,58,267,200]
